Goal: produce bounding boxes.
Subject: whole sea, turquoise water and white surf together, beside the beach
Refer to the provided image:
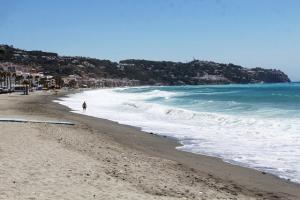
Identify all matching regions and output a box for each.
[58,83,300,183]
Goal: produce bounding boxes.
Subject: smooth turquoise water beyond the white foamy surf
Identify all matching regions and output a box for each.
[121,83,300,117]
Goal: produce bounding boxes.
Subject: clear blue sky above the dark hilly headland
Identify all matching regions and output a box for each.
[0,0,300,81]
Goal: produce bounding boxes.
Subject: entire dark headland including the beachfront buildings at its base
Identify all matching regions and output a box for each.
[0,45,290,93]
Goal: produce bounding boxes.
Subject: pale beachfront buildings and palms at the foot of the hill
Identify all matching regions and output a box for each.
[0,62,139,94]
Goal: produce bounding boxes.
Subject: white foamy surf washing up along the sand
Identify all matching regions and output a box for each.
[55,89,300,183]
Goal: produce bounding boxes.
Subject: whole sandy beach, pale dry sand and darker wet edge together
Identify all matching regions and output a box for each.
[0,91,300,199]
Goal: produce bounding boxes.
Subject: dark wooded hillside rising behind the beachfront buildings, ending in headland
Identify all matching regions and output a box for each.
[0,45,290,85]
